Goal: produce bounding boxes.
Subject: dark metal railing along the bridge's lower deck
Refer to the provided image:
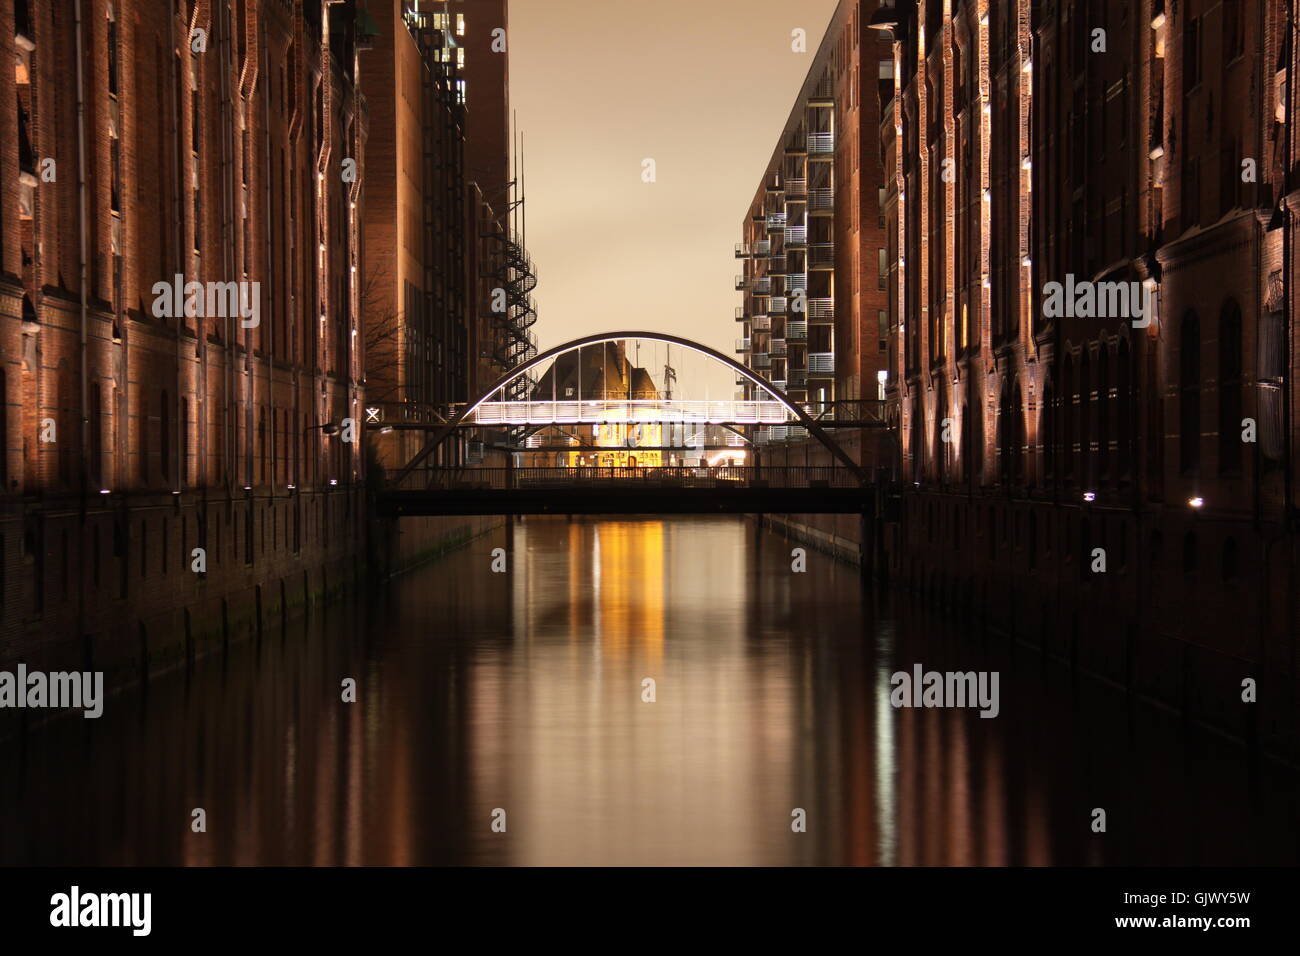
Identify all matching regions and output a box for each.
[386,464,861,493]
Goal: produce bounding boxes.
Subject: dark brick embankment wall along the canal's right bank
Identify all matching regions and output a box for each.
[757,442,1300,762]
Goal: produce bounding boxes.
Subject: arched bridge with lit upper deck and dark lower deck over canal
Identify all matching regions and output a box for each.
[371,332,885,516]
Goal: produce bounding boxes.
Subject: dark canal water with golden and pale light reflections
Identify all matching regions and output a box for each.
[0,519,1300,865]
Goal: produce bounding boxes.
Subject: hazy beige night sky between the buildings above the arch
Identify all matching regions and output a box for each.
[510,0,836,398]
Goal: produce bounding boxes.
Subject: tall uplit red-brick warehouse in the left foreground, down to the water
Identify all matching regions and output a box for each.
[0,0,501,686]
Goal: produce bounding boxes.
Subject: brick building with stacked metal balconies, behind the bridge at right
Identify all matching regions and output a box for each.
[736,0,888,416]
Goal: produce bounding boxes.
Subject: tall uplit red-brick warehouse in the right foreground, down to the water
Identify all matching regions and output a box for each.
[857,0,1296,732]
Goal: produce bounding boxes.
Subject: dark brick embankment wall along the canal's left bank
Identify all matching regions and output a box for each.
[0,486,503,688]
